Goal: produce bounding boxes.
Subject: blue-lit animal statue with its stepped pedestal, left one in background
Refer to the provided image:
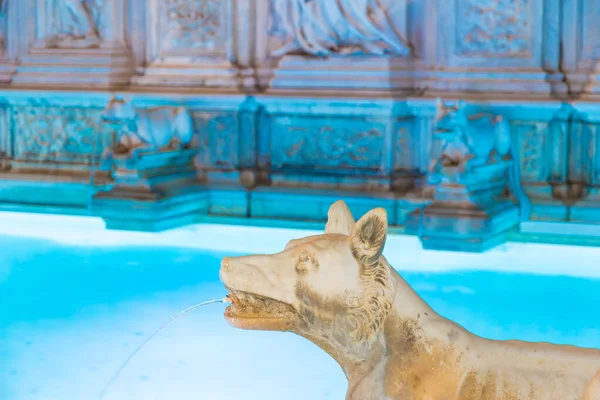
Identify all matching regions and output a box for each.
[92,98,206,231]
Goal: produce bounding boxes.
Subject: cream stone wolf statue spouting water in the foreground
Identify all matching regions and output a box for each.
[220,202,600,400]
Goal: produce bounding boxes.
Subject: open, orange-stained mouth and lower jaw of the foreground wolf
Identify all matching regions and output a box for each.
[225,288,296,330]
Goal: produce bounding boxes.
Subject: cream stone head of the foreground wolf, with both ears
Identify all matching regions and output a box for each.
[220,201,395,347]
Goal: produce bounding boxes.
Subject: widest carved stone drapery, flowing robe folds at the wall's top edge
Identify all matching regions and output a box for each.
[269,0,411,58]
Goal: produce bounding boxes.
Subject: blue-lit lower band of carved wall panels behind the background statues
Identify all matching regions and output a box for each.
[0,89,600,252]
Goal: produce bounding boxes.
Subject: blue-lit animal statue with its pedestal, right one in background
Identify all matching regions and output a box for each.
[404,101,531,252]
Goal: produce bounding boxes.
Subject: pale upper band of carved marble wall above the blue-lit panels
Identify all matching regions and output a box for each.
[0,0,600,92]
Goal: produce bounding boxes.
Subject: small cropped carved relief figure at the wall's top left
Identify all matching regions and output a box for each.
[46,0,100,48]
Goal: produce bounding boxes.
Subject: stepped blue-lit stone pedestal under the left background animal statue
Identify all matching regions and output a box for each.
[92,149,208,231]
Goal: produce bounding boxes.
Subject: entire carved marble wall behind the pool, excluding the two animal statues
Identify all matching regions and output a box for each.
[0,0,600,250]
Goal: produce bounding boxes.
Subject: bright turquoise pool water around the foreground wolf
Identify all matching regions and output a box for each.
[0,222,600,400]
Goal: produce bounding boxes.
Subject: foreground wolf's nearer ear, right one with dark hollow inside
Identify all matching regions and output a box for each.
[350,208,388,265]
